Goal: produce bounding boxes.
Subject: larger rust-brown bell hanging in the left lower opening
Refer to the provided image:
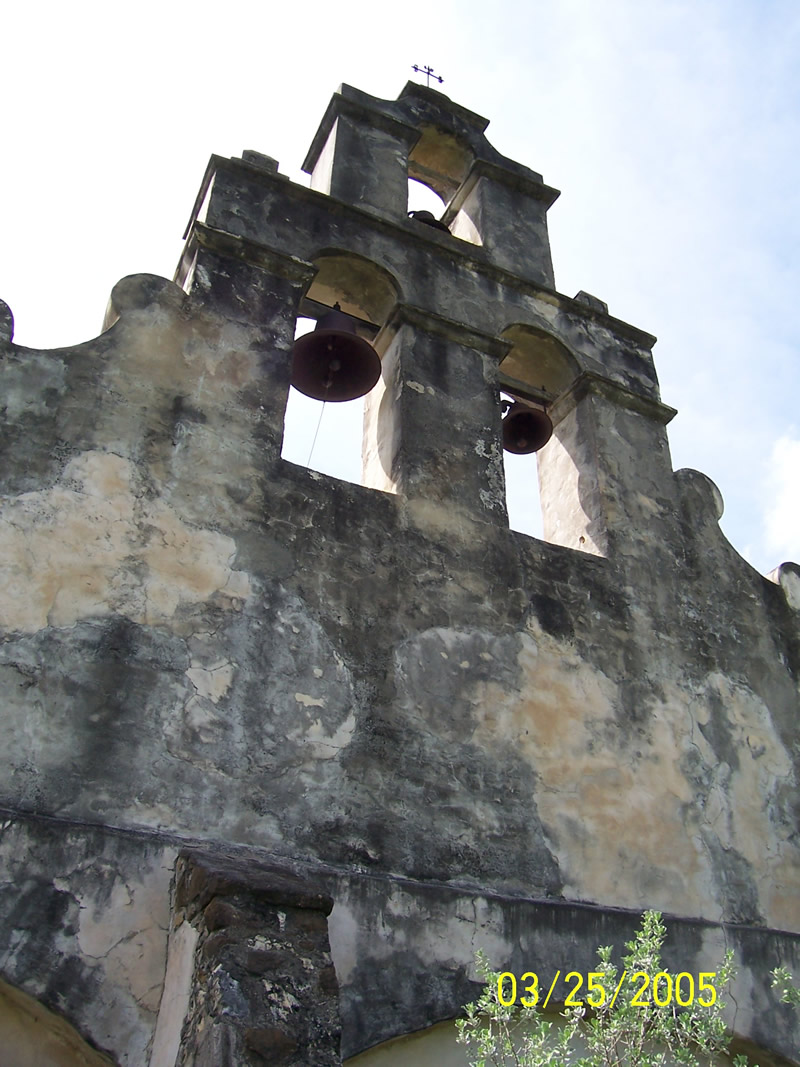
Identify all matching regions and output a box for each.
[291,304,381,402]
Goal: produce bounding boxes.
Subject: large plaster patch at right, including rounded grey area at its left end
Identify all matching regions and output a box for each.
[397,627,800,928]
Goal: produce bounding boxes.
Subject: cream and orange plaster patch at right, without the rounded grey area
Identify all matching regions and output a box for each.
[501,638,797,926]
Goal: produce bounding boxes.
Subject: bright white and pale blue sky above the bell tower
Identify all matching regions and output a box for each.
[0,0,800,572]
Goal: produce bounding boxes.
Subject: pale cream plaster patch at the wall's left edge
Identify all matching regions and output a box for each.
[0,451,251,633]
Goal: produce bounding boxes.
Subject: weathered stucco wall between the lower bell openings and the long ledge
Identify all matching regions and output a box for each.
[0,279,798,928]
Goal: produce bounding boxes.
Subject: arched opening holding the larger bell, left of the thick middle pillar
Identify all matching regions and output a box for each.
[281,250,399,484]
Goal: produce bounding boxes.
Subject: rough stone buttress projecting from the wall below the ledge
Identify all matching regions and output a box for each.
[154,853,341,1067]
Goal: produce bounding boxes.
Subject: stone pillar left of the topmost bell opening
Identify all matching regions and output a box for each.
[303,85,419,219]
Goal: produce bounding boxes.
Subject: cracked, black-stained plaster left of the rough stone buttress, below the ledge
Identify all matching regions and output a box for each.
[0,819,174,1067]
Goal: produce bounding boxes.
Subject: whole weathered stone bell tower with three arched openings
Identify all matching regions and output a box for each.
[0,78,800,1067]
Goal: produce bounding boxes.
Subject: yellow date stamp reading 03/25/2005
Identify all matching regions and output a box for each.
[497,970,717,1010]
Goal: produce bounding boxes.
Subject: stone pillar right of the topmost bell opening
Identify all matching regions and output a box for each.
[444,159,559,289]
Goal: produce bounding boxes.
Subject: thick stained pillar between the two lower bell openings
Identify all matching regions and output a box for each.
[363,305,509,527]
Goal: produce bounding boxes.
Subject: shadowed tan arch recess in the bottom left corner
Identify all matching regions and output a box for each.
[0,980,114,1067]
